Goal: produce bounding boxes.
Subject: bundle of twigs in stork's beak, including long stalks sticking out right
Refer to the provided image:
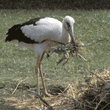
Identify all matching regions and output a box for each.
[47,30,108,65]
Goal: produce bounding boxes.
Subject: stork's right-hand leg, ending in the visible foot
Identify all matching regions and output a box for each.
[39,52,51,96]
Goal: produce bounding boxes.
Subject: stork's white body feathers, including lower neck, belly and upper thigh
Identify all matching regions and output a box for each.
[19,17,71,56]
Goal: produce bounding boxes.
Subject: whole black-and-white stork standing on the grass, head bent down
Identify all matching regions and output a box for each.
[5,16,75,96]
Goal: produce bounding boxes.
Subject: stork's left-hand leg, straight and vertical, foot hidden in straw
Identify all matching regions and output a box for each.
[35,55,40,94]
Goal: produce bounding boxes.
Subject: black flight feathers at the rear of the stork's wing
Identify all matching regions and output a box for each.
[5,17,43,44]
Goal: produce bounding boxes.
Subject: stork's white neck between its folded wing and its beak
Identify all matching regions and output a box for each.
[60,25,71,44]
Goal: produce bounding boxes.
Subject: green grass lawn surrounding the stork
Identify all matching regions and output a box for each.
[0,10,110,101]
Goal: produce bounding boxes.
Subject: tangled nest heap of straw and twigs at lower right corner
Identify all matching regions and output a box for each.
[74,70,110,110]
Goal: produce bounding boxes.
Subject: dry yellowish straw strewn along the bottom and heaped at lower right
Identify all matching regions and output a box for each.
[0,69,110,110]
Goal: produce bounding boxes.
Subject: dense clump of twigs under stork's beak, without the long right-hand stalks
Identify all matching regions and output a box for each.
[47,43,87,65]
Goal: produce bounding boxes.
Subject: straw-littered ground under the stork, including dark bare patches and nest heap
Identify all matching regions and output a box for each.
[0,69,110,110]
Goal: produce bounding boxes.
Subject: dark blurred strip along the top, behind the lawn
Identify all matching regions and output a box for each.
[0,0,110,10]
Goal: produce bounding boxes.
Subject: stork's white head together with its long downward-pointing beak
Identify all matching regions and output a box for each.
[63,16,75,46]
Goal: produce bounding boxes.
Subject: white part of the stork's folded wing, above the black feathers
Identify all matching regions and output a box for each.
[21,17,62,42]
